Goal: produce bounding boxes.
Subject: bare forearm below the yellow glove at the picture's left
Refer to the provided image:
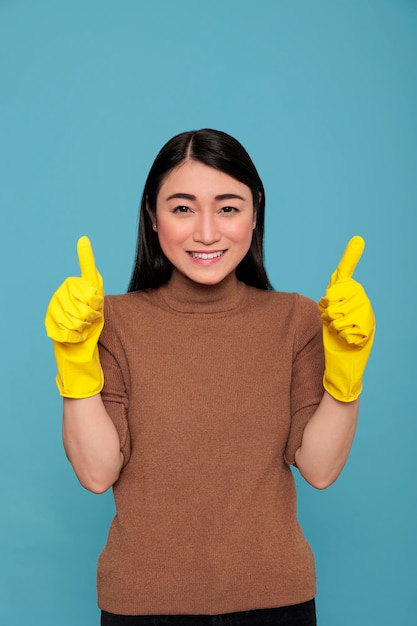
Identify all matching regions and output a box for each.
[62,394,123,493]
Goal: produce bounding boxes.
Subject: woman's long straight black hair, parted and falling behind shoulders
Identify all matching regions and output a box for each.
[128,128,272,291]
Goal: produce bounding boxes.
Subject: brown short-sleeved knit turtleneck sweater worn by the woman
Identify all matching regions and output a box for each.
[98,271,323,615]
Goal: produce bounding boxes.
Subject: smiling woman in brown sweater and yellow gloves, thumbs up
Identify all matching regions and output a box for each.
[46,129,375,626]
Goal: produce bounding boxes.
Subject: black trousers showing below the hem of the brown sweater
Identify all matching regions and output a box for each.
[101,599,317,626]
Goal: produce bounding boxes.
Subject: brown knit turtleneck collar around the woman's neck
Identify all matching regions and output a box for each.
[158,268,245,314]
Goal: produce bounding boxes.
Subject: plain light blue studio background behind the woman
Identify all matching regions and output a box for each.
[0,0,417,626]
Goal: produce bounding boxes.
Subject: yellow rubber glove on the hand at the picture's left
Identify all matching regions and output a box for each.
[45,237,104,398]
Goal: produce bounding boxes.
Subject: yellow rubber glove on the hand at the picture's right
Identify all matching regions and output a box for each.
[319,237,375,402]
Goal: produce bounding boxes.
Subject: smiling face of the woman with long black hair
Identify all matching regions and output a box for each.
[151,160,256,285]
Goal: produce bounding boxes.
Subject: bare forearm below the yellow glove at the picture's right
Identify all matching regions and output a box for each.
[295,392,359,489]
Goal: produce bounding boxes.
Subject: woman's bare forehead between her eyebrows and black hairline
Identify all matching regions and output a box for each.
[158,160,252,198]
